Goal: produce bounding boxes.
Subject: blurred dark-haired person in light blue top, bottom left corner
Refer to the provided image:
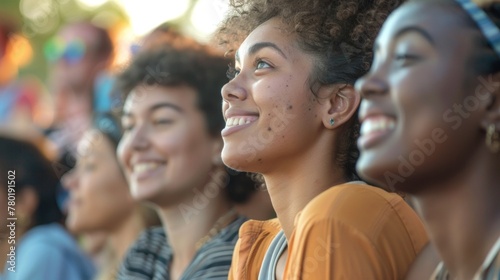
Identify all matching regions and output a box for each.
[0,136,94,280]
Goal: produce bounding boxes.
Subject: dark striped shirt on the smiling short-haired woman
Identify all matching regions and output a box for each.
[117,217,246,280]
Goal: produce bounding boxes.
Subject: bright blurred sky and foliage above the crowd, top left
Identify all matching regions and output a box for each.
[0,0,228,80]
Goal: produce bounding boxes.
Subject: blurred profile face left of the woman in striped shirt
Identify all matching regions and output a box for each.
[63,129,135,233]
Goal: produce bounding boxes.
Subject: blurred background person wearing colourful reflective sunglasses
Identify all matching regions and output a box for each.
[44,21,114,175]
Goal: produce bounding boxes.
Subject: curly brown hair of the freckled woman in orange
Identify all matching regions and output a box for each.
[216,0,403,180]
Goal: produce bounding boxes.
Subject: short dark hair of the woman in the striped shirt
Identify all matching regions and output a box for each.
[116,47,230,136]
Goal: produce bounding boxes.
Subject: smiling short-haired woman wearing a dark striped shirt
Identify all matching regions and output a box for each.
[117,47,250,279]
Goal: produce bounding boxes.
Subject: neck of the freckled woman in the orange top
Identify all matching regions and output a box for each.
[263,135,347,239]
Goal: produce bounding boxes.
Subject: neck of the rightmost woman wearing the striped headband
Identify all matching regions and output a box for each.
[416,153,500,279]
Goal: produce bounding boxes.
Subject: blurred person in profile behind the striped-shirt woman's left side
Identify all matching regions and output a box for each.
[63,113,160,279]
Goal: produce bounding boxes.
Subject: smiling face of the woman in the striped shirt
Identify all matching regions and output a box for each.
[118,85,221,207]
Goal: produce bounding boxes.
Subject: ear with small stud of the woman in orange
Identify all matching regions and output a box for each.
[322,84,361,129]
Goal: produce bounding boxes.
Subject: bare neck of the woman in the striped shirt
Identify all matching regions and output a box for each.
[158,191,234,274]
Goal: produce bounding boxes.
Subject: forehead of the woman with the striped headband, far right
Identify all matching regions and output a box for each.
[376,1,480,51]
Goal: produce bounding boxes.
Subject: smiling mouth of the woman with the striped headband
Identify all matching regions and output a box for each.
[358,115,396,149]
